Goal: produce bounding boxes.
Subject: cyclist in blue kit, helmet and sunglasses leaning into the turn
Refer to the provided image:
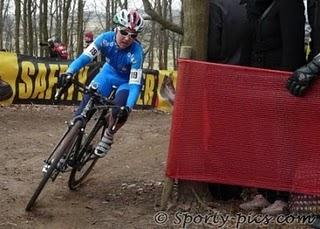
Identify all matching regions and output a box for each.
[57,9,144,157]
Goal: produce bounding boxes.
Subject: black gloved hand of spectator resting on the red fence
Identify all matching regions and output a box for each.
[287,54,320,96]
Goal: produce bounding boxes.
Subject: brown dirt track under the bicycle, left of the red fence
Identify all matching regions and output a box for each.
[0,106,171,229]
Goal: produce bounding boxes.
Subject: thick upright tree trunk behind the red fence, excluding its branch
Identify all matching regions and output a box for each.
[160,0,211,210]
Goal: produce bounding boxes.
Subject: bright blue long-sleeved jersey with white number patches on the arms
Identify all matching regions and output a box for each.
[67,31,143,108]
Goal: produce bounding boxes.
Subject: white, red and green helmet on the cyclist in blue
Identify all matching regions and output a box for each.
[113,9,144,33]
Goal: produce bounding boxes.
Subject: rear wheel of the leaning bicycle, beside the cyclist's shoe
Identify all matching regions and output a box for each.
[68,112,106,190]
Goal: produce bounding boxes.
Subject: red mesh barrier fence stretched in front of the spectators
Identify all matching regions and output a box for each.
[166,60,320,194]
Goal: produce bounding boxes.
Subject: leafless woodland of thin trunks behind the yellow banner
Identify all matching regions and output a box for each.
[0,0,183,70]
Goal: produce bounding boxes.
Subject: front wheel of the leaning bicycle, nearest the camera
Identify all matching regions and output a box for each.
[25,120,82,211]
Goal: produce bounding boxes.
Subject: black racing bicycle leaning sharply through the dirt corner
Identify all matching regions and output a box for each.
[25,79,119,211]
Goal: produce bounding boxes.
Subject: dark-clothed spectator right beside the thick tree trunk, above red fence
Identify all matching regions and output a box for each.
[207,0,248,65]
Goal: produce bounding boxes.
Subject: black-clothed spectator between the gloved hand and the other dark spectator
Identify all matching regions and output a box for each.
[241,0,306,71]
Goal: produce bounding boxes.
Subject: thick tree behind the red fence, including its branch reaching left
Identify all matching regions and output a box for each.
[143,0,210,209]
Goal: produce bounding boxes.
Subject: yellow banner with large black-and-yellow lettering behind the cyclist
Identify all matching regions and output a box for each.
[0,52,176,111]
